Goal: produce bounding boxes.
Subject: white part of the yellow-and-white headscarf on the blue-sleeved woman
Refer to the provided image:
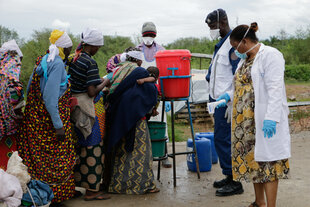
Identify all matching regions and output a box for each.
[47,32,72,62]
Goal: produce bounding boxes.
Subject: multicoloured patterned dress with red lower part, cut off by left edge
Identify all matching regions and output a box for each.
[0,52,24,170]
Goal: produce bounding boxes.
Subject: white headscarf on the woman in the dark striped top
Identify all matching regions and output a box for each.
[81,28,104,46]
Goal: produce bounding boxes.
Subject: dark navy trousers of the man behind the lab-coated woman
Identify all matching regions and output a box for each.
[210,97,232,175]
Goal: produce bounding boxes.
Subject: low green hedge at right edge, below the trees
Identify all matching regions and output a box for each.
[285,64,310,81]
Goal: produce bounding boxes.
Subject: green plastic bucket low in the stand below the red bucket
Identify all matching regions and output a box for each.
[148,121,167,157]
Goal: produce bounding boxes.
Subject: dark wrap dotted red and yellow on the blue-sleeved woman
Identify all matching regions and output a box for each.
[17,56,76,203]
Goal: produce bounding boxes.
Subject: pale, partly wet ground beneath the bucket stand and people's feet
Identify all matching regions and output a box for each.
[64,131,310,207]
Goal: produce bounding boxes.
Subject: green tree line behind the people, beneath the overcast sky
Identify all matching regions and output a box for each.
[0,26,310,88]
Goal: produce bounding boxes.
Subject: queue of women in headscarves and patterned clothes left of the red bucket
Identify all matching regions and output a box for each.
[0,23,159,206]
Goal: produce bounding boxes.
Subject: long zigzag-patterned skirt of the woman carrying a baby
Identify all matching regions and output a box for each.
[109,120,156,194]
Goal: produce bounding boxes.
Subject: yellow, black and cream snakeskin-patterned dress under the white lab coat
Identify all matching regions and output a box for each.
[231,59,289,183]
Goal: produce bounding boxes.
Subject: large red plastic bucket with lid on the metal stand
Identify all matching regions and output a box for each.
[155,50,191,98]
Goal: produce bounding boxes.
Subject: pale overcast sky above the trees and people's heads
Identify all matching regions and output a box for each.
[0,0,310,44]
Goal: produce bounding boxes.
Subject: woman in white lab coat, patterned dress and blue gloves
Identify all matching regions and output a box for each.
[218,23,291,207]
